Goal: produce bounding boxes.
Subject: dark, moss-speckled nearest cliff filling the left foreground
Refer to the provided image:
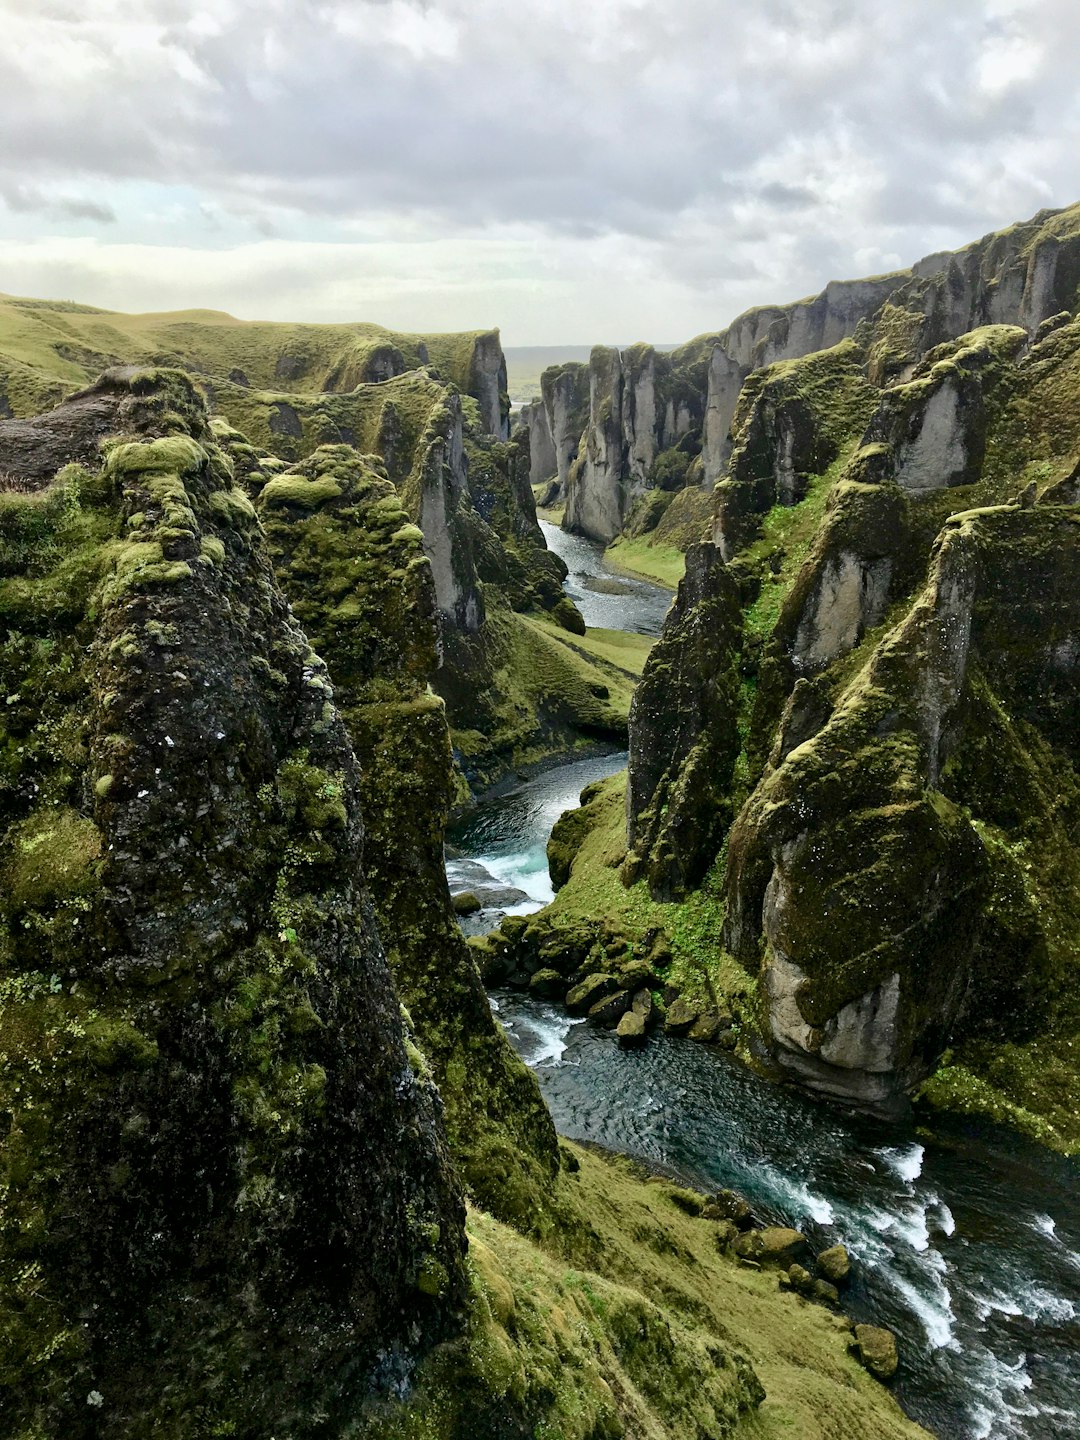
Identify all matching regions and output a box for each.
[0,373,465,1436]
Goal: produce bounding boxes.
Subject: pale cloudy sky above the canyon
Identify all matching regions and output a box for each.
[0,0,1080,344]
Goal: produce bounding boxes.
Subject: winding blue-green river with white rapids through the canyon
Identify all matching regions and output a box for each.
[448,527,1080,1440]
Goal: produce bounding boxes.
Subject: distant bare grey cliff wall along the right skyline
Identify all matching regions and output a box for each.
[549,207,1080,555]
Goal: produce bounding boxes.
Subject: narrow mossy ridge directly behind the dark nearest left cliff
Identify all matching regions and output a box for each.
[258,446,556,1228]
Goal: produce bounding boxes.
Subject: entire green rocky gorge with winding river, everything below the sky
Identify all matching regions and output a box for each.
[0,194,1080,1440]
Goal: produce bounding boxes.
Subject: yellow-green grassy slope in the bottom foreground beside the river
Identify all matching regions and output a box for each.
[357,1142,926,1440]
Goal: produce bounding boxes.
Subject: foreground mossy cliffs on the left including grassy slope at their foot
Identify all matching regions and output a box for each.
[0,370,922,1440]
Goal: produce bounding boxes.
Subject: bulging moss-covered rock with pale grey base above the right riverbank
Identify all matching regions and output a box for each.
[726,507,1080,1097]
